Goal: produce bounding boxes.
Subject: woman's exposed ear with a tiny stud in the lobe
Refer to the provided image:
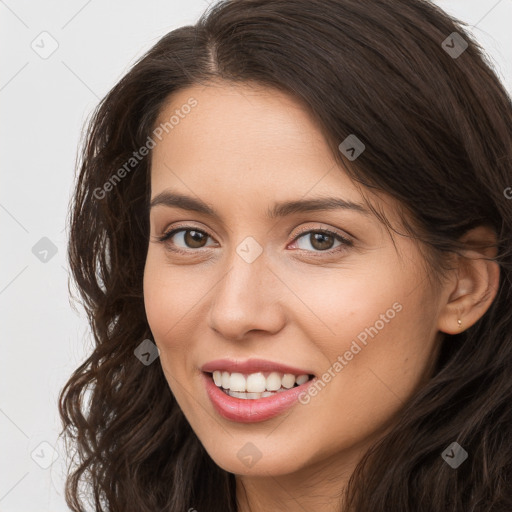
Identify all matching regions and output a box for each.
[437,226,500,334]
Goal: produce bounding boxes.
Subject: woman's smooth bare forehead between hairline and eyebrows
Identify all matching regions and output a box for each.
[151,84,360,204]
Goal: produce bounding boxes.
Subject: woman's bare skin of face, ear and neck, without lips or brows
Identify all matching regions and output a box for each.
[144,83,499,512]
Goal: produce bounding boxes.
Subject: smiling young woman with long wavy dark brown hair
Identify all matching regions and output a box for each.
[60,0,512,512]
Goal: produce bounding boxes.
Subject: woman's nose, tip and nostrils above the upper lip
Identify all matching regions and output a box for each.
[209,246,286,341]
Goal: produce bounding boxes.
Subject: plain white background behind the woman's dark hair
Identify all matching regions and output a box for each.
[0,0,512,512]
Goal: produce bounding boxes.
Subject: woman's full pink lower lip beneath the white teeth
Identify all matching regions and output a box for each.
[203,372,315,423]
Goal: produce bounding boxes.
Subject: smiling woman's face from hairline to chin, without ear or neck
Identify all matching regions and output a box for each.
[144,84,443,475]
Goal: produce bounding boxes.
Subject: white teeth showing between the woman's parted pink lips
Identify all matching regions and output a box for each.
[204,370,315,400]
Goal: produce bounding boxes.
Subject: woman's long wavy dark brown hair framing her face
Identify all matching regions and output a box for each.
[59,0,512,512]
